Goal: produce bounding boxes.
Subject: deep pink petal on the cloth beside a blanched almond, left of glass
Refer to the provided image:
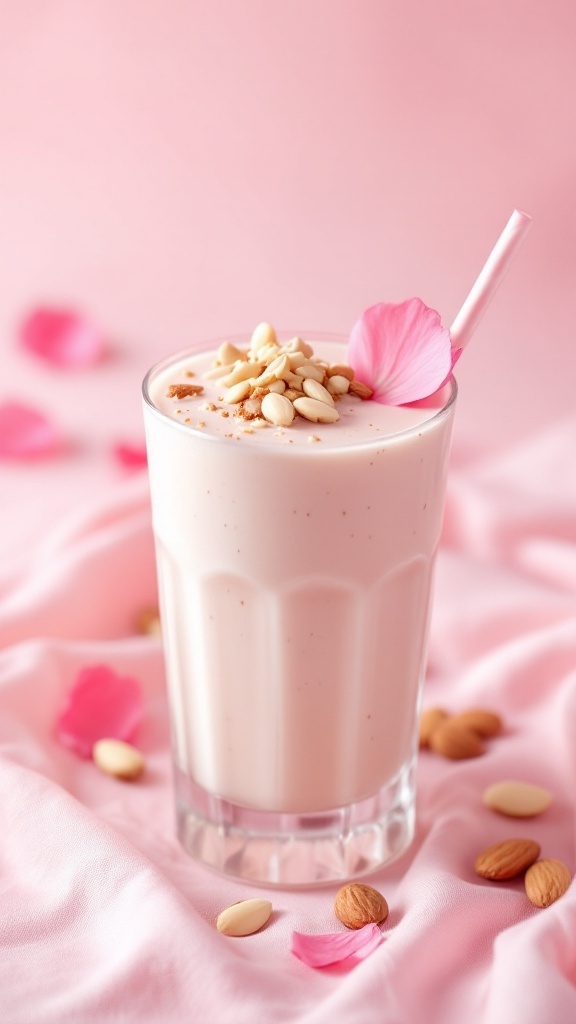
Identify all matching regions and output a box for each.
[56,665,142,758]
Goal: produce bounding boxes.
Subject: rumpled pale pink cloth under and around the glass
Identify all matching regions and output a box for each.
[0,419,576,1024]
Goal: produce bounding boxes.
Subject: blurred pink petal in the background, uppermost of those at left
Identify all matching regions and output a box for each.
[19,306,105,370]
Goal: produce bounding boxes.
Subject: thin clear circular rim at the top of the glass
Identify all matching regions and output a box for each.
[141,330,458,455]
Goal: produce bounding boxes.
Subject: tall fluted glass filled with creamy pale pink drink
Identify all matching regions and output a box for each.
[145,329,455,885]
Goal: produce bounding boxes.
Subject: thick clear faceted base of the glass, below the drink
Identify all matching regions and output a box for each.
[174,761,415,888]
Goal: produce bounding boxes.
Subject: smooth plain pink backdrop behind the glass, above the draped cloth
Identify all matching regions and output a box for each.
[0,0,576,557]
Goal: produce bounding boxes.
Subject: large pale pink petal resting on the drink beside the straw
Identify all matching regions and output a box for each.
[348,299,452,406]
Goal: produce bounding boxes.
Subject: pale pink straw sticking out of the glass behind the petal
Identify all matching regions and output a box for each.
[450,210,532,348]
